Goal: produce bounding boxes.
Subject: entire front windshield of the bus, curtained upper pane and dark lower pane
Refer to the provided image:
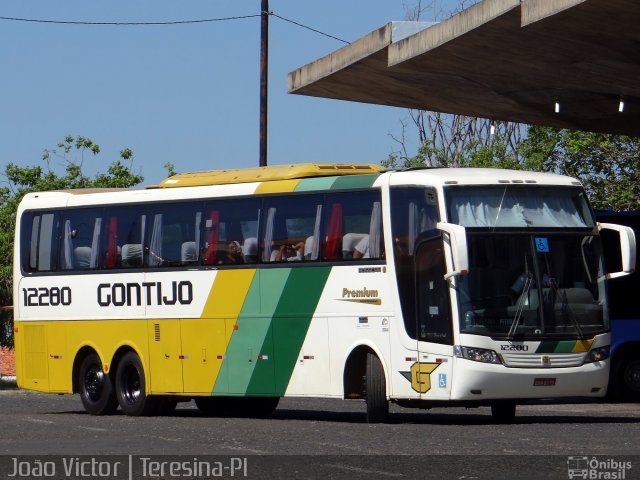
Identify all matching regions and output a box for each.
[446,184,609,339]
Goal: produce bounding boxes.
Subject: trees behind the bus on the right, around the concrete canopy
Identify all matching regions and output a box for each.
[390,0,640,214]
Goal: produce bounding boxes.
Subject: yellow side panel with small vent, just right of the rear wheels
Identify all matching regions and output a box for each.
[147,319,183,394]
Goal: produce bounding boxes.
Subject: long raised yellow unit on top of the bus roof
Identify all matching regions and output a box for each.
[146,163,385,188]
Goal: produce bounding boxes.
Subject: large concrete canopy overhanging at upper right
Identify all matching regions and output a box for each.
[289,0,640,136]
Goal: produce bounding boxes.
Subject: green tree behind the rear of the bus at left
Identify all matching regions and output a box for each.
[0,135,143,345]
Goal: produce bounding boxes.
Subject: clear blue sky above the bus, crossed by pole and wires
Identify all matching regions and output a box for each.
[0,0,456,185]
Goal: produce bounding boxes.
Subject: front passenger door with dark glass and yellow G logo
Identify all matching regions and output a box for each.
[411,237,453,399]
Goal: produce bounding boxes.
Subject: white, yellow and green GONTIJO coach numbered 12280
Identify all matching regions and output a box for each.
[14,164,635,422]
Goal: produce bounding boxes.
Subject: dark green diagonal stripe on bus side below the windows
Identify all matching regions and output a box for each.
[247,267,331,396]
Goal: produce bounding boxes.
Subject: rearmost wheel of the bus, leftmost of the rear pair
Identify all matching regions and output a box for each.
[77,353,118,415]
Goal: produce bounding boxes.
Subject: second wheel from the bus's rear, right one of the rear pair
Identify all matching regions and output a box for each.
[116,352,158,417]
